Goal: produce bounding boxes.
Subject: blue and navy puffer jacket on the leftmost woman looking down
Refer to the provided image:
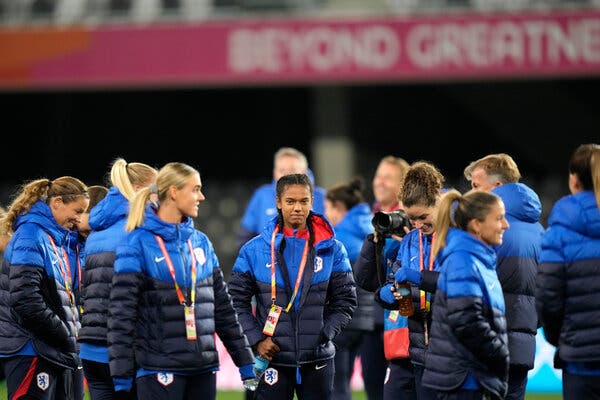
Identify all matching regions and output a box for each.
[0,201,79,369]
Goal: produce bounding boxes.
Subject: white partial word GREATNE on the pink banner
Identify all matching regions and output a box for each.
[405,19,600,69]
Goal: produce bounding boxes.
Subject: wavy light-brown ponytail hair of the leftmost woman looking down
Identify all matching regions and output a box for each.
[0,176,89,236]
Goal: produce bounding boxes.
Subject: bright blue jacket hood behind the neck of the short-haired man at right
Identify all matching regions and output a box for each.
[492,182,542,222]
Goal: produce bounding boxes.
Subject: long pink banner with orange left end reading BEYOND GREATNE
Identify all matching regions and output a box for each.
[0,10,600,88]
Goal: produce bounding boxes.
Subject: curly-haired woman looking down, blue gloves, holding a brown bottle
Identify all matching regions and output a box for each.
[375,161,444,400]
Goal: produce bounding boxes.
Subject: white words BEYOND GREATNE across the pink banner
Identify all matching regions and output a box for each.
[228,17,600,73]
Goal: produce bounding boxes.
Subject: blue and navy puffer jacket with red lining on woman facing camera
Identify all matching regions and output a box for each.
[229,212,357,366]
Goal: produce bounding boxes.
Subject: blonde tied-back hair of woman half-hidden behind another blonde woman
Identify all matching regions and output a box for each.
[110,158,158,201]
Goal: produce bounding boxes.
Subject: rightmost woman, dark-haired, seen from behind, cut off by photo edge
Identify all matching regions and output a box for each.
[536,143,600,400]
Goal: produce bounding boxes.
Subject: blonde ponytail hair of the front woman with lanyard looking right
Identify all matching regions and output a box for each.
[125,162,200,231]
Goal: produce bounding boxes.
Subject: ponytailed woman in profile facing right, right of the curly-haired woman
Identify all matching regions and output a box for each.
[422,190,509,400]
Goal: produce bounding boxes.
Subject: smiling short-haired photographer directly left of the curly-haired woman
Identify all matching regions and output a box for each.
[354,156,416,400]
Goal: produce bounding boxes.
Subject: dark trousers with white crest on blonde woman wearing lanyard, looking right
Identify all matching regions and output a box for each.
[136,372,217,400]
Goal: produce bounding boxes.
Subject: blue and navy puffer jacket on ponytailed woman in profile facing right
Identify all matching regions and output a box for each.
[422,228,509,399]
